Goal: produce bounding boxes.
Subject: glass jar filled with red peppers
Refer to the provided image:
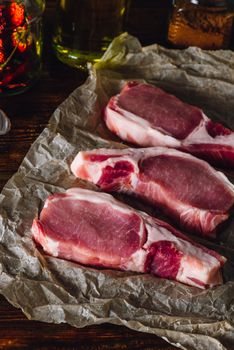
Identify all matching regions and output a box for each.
[0,0,45,96]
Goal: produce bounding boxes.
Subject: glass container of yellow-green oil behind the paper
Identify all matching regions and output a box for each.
[53,0,126,68]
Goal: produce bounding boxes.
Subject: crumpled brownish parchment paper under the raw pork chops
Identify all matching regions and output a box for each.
[0,34,234,350]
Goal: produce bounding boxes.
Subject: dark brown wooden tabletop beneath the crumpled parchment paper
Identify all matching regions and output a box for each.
[0,1,176,350]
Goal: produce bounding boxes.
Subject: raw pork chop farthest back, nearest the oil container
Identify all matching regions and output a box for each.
[104,82,234,168]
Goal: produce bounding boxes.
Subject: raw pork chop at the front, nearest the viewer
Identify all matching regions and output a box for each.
[32,188,226,288]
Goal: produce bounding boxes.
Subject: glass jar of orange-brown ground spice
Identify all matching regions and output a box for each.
[168,0,233,50]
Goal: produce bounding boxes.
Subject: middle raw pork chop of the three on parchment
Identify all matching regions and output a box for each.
[71,147,234,236]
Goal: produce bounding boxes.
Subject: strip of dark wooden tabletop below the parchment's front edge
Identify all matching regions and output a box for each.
[0,297,175,350]
